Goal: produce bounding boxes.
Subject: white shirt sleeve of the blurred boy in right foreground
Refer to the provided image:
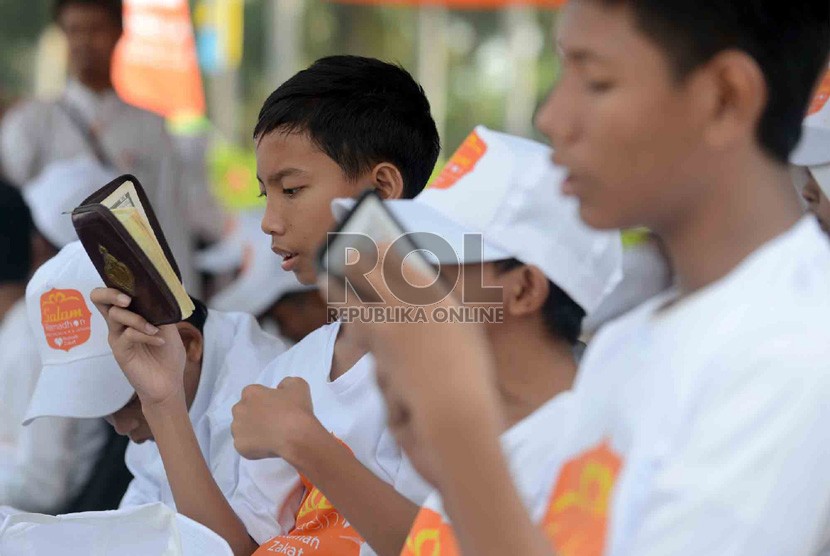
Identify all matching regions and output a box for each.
[624,334,830,556]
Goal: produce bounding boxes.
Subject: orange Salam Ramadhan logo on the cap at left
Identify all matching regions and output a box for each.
[40,289,92,351]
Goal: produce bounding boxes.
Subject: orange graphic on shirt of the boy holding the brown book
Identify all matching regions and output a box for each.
[254,444,363,556]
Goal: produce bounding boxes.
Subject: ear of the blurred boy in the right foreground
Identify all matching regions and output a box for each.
[703,50,769,153]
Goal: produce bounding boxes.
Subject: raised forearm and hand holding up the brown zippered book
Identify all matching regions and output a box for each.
[91,288,257,556]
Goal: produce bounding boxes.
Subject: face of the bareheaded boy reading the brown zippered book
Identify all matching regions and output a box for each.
[256,130,371,284]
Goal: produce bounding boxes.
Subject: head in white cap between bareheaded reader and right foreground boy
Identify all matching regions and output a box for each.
[334,126,622,430]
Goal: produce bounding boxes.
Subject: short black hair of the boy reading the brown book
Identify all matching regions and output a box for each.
[254,56,441,198]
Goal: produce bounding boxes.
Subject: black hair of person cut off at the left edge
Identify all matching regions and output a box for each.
[0,180,35,283]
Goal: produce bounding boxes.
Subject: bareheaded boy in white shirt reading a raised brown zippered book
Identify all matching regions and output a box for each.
[92,56,439,554]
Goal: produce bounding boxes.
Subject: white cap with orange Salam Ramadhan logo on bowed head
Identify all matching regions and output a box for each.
[23,241,135,425]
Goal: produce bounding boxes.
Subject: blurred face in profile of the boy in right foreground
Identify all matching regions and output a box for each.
[536,0,712,228]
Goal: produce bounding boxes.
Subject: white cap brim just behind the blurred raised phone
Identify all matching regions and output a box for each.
[331,199,514,265]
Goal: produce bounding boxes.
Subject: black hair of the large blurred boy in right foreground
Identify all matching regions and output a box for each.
[590,0,830,163]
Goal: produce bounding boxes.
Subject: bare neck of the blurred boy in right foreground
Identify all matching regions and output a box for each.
[652,148,802,295]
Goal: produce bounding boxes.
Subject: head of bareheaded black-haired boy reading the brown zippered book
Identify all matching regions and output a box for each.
[254,56,440,284]
